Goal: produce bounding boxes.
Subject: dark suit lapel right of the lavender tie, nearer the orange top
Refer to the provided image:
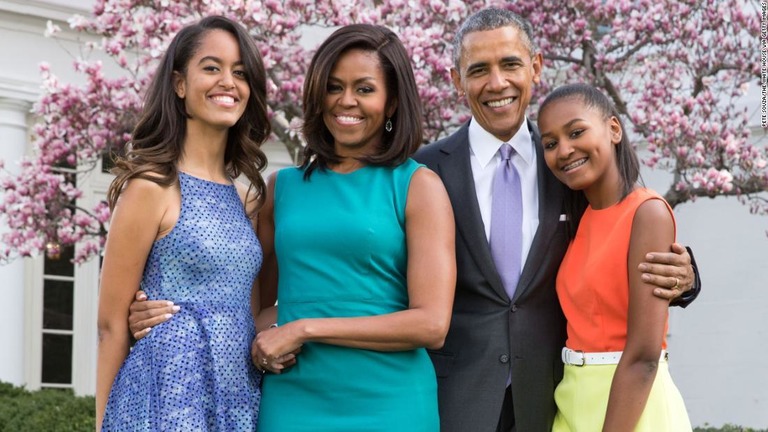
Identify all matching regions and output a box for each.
[513,121,563,301]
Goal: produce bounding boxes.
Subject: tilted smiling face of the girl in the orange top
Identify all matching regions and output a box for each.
[538,97,623,208]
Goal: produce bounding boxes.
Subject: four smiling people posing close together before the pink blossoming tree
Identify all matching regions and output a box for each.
[97,8,696,432]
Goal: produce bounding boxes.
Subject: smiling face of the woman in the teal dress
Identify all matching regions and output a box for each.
[323,49,394,157]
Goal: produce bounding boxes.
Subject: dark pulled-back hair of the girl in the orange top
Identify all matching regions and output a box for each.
[539,83,642,238]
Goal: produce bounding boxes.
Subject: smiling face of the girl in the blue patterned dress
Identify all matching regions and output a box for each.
[174,30,250,129]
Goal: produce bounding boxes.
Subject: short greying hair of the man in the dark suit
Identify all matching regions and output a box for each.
[453,8,539,71]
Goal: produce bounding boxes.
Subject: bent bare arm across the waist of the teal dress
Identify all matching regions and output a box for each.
[256,169,456,358]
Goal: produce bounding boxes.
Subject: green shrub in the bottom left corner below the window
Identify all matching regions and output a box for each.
[0,382,95,432]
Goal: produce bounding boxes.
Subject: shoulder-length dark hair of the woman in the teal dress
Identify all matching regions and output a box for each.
[301,24,423,179]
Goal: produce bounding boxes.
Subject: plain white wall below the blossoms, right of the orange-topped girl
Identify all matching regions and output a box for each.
[643,150,768,428]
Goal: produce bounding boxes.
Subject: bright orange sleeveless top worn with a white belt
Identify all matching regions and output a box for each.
[557,188,677,352]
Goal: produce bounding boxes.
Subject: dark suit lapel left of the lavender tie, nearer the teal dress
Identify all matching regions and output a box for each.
[438,123,507,299]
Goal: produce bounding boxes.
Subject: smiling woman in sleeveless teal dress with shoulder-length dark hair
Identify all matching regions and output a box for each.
[252,25,456,432]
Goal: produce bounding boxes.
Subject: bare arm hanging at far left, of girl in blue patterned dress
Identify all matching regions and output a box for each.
[96,179,168,430]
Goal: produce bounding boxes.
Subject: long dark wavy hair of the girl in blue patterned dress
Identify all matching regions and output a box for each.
[107,16,271,217]
